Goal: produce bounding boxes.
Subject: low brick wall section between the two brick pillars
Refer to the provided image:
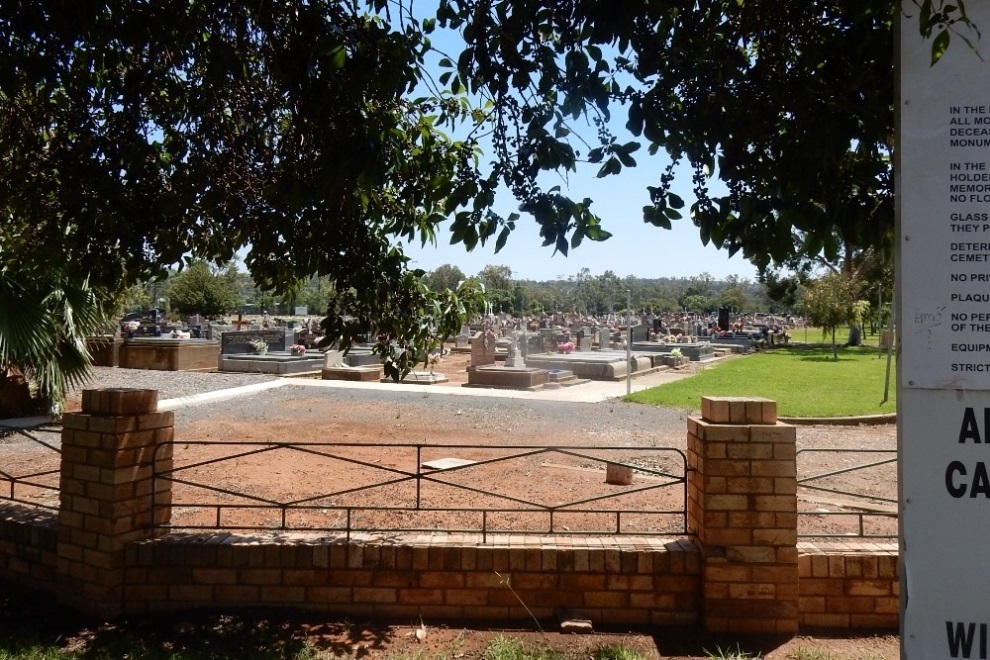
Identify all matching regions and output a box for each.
[125,535,700,625]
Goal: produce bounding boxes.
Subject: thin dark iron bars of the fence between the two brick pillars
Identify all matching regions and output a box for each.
[152,441,687,537]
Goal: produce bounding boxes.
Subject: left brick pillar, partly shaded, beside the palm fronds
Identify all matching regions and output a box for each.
[56,389,173,618]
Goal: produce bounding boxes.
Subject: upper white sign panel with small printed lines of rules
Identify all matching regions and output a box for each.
[898,5,990,389]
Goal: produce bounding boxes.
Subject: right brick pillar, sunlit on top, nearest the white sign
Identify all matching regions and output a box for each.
[688,397,798,633]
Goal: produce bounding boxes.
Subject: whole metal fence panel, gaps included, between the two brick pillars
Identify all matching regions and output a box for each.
[152,441,687,541]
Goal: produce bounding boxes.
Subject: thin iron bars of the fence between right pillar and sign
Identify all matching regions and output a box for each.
[797,447,897,539]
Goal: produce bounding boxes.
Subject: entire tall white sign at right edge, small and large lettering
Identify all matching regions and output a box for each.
[896,0,990,659]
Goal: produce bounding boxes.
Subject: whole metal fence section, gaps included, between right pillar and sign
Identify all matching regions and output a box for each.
[797,447,897,539]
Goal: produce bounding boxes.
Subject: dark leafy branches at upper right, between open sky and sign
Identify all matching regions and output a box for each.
[439,0,899,266]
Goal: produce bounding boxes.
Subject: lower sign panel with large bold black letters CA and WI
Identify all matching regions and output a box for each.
[897,388,990,660]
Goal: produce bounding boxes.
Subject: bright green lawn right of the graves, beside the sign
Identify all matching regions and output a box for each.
[626,346,896,417]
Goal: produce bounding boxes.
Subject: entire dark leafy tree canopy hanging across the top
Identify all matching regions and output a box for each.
[0,0,971,408]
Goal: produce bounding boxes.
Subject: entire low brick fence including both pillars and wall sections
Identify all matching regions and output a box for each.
[0,390,899,633]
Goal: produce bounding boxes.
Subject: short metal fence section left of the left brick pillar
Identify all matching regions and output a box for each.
[0,421,62,511]
